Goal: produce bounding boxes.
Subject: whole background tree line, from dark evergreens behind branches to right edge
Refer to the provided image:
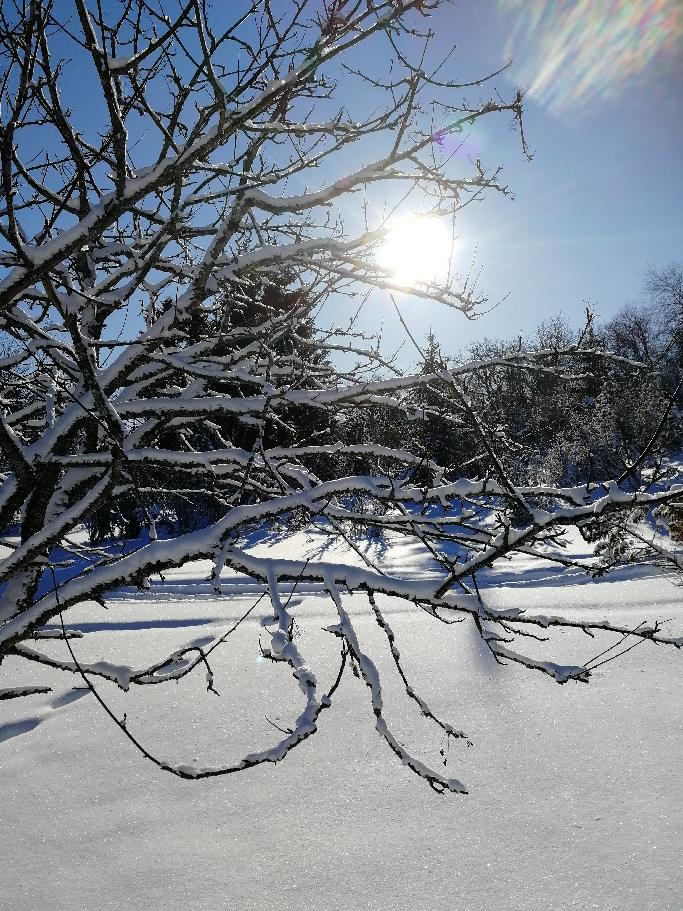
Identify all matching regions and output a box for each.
[71,264,683,541]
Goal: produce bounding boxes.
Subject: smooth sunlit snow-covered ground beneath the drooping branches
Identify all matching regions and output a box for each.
[0,535,683,911]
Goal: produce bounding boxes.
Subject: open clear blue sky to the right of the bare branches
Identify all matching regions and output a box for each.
[348,0,683,350]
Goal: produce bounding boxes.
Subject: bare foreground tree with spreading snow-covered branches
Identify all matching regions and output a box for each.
[0,0,683,792]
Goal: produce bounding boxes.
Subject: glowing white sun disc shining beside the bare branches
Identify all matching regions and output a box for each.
[377,216,453,288]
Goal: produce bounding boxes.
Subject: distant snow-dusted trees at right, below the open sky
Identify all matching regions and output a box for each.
[342,265,683,496]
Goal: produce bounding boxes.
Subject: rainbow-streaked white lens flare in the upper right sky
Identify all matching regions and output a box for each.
[498,0,683,113]
